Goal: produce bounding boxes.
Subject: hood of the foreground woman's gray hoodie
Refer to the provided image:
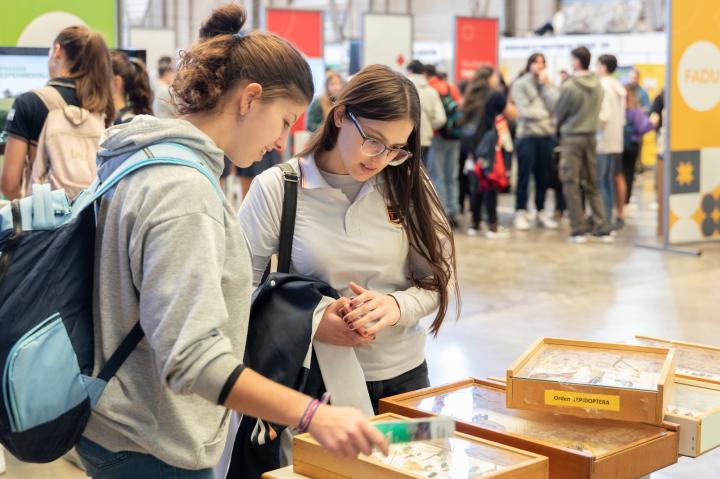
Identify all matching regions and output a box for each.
[97,115,225,180]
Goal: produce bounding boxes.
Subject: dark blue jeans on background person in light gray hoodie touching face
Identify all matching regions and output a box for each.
[515,136,555,211]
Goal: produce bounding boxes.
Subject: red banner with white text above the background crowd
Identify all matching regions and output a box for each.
[455,17,499,81]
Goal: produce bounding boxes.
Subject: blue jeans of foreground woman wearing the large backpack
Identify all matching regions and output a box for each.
[75,437,213,479]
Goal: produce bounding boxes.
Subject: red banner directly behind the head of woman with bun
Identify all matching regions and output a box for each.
[266,8,324,58]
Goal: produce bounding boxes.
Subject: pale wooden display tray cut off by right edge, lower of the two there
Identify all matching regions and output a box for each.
[665,378,720,457]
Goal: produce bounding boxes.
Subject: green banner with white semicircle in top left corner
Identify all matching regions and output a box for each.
[0,0,116,48]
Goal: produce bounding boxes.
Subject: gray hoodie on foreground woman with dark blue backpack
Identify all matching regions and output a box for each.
[84,116,252,469]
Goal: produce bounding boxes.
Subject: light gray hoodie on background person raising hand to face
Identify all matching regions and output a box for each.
[511,73,558,138]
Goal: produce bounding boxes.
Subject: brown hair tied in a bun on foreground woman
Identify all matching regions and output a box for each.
[171,3,314,114]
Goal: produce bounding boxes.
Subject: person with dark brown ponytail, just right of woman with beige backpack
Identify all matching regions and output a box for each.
[110,50,153,125]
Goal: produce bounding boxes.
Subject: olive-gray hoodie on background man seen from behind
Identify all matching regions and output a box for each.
[555,73,603,135]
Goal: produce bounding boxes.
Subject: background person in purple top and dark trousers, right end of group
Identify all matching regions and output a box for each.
[618,83,653,208]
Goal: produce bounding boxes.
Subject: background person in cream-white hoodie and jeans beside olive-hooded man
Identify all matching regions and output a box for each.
[597,55,627,229]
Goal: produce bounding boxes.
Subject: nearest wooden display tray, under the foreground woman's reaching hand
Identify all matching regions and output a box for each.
[293,414,548,479]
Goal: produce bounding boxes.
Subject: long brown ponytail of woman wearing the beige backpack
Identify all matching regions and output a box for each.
[53,26,115,126]
